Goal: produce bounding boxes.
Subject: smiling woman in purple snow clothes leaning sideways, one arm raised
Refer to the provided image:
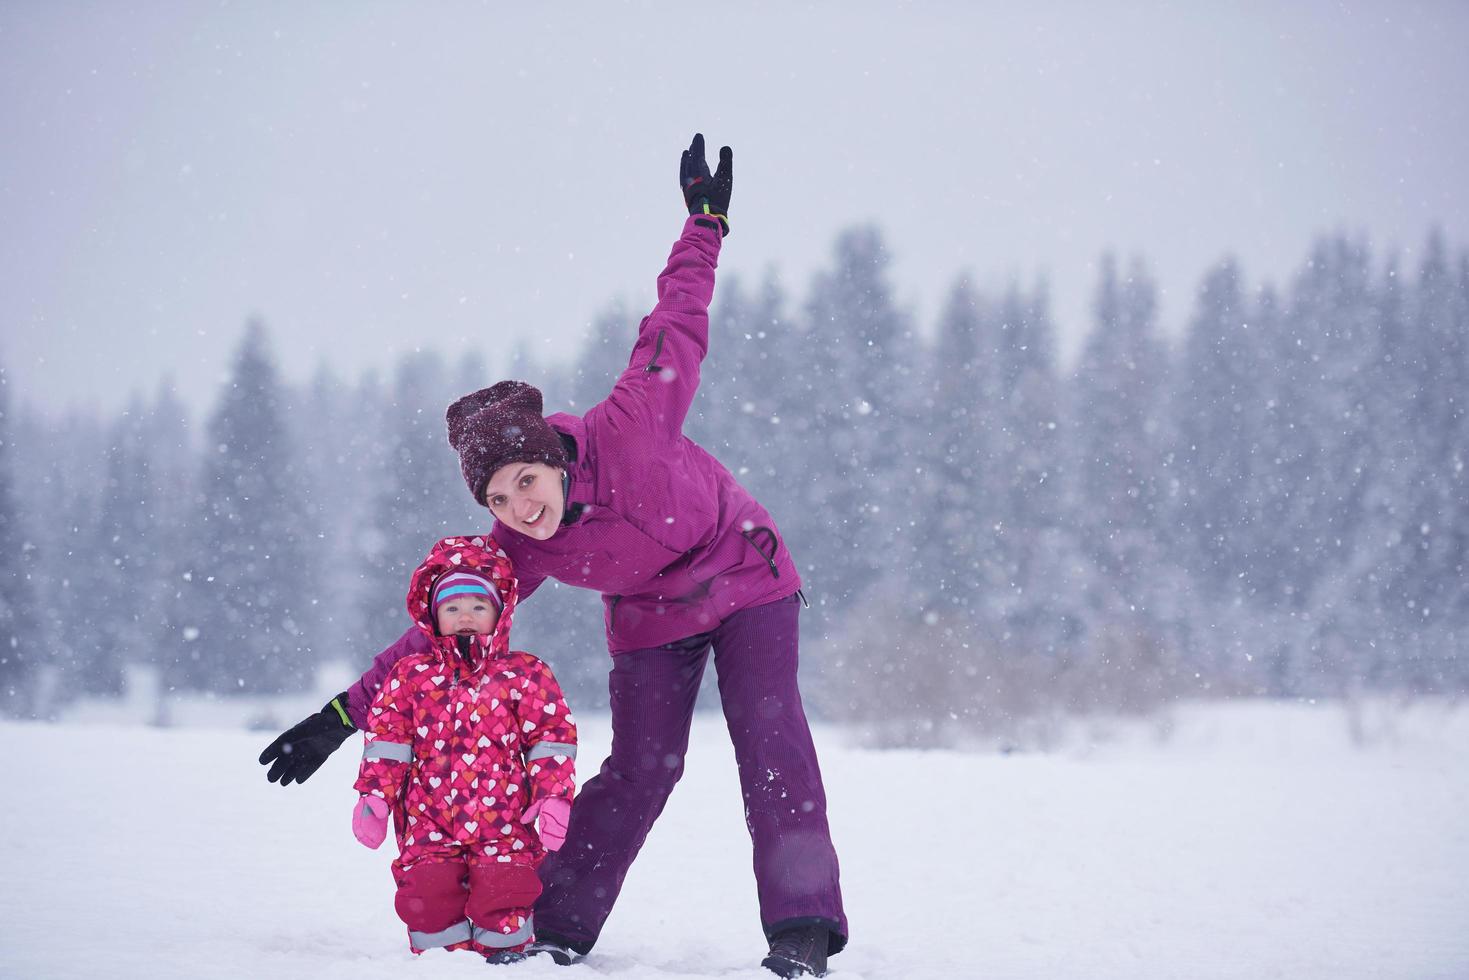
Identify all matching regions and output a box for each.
[261,135,848,977]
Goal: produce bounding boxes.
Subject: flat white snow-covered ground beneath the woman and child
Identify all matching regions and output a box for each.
[0,704,1469,980]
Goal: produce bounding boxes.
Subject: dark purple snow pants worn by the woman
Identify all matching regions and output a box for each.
[535,595,846,954]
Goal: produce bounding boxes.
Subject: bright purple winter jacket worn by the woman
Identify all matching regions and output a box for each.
[347,216,801,727]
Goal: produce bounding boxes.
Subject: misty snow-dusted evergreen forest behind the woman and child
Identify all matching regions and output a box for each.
[0,228,1469,745]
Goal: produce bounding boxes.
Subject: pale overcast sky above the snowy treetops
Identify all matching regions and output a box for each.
[0,0,1469,410]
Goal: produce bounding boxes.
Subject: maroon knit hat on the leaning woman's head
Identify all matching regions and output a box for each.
[445,381,567,504]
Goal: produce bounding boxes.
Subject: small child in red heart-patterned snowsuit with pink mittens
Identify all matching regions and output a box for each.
[353,538,576,962]
